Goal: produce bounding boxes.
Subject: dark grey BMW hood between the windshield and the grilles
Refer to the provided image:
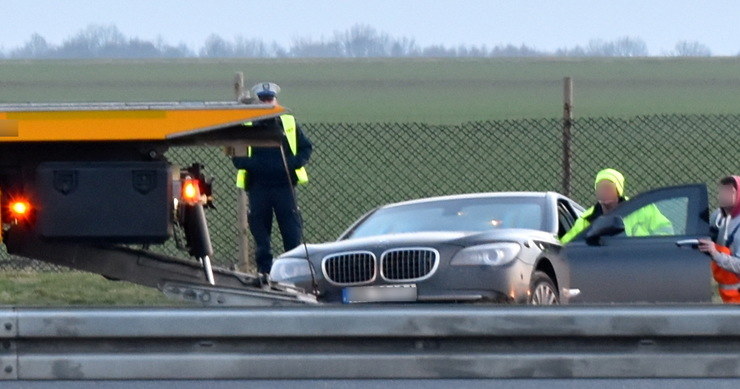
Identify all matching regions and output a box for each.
[279,228,557,258]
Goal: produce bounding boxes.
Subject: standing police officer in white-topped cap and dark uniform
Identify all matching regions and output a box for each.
[232,82,313,274]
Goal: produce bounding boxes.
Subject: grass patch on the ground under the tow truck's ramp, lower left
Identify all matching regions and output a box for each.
[0,271,183,306]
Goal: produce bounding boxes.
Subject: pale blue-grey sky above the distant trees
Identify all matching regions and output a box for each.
[0,0,740,55]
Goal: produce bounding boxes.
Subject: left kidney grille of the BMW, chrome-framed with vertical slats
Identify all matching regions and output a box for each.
[322,251,377,285]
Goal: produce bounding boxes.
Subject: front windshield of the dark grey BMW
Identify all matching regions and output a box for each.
[346,196,545,238]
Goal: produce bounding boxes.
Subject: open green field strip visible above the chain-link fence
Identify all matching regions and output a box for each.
[0,57,740,124]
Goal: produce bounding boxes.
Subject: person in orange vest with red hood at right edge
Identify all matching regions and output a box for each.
[699,176,740,304]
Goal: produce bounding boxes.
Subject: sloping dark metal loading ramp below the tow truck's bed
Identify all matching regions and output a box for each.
[7,230,317,306]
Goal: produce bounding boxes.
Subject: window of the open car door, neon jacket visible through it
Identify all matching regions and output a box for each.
[621,197,689,237]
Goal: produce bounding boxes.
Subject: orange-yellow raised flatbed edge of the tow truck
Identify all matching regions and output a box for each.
[0,102,286,143]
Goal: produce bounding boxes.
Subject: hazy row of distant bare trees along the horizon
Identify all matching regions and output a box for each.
[0,24,724,59]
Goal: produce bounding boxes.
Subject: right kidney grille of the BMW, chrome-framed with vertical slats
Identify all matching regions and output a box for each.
[380,248,439,281]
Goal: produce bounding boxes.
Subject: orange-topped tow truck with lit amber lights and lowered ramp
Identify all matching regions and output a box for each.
[0,102,316,306]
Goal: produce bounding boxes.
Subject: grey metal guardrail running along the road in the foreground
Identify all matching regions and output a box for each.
[0,305,740,387]
